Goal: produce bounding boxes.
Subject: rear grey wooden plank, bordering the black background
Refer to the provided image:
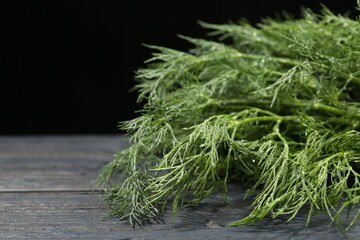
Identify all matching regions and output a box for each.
[0,135,128,190]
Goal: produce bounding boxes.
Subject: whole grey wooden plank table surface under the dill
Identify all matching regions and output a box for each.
[0,135,360,240]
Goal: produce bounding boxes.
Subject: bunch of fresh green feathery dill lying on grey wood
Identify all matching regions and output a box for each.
[98,3,360,232]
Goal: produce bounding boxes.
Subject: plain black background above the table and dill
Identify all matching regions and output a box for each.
[0,0,357,134]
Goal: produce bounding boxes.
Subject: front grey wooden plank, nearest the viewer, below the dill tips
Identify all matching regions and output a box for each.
[0,189,360,240]
